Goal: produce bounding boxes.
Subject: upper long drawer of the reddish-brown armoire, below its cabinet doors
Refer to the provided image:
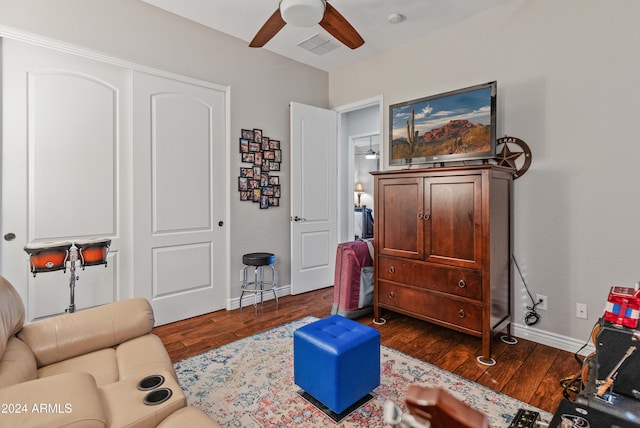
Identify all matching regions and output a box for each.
[378,256,482,300]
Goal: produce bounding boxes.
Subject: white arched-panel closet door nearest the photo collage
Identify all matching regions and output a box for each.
[133,72,228,325]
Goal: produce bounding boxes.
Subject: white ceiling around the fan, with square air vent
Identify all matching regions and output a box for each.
[142,0,512,71]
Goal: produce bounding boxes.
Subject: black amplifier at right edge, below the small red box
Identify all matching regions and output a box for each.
[596,320,640,400]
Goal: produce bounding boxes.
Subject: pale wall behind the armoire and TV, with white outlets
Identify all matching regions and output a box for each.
[329,0,640,350]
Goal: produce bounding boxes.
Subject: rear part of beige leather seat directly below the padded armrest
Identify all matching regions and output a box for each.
[38,348,120,387]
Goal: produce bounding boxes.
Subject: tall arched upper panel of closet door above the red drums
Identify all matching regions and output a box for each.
[27,71,118,239]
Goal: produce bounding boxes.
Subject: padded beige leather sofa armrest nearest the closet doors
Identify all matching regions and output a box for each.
[18,298,154,367]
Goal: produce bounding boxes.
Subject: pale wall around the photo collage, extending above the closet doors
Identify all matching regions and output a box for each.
[0,0,328,298]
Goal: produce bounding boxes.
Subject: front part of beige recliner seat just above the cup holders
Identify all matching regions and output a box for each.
[116,334,176,379]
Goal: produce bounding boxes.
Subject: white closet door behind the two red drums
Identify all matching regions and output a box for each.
[0,40,131,321]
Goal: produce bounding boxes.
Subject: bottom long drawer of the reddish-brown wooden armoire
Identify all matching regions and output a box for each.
[378,281,482,332]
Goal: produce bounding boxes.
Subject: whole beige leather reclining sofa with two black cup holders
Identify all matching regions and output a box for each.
[0,276,219,428]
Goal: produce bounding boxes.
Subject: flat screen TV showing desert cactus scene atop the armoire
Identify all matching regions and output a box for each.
[389,82,497,165]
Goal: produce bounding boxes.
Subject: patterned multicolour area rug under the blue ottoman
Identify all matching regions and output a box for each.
[175,317,552,428]
